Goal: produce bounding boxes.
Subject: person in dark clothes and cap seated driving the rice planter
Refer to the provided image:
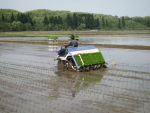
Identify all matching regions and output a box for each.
[58,35,78,56]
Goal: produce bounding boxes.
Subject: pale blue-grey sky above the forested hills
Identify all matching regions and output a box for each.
[0,0,150,17]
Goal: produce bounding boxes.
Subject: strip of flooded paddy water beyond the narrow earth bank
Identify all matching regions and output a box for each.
[0,34,150,46]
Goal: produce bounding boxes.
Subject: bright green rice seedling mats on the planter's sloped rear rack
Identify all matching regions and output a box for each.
[74,52,105,66]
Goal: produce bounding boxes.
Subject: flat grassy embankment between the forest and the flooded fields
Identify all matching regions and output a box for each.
[0,30,150,37]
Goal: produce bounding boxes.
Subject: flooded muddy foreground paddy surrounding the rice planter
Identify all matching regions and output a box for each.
[0,42,150,113]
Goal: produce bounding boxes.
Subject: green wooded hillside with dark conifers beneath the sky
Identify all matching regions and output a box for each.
[0,9,150,32]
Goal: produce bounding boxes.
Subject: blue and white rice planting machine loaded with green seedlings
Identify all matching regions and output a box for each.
[56,45,106,72]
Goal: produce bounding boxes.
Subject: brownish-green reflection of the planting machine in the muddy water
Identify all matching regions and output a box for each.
[51,64,105,98]
